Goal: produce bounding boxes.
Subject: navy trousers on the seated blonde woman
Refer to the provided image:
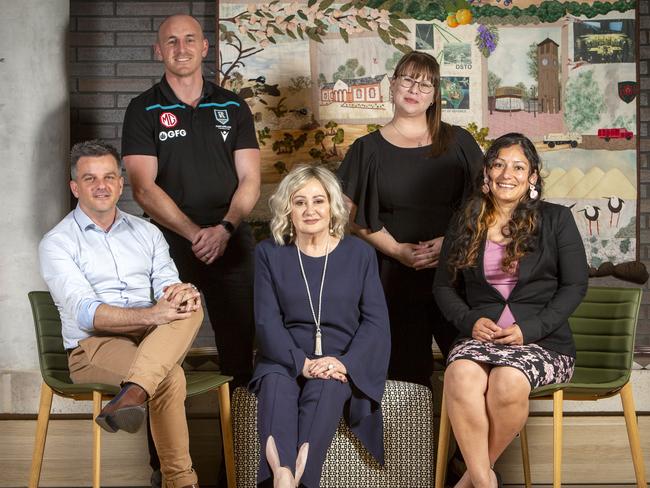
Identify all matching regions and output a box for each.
[257,373,352,488]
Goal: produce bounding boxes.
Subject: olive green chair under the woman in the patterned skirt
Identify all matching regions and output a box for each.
[435,287,646,488]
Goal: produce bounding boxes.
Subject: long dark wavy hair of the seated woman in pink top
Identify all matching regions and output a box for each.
[447,132,543,281]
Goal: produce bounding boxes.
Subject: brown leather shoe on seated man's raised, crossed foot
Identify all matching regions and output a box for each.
[95,383,147,434]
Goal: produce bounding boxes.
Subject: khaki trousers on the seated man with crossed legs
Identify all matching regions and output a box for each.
[68,310,203,488]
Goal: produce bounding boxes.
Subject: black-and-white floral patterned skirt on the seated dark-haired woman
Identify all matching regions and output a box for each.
[447,339,575,388]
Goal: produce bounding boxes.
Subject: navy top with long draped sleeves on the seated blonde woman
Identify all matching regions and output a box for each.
[249,236,390,464]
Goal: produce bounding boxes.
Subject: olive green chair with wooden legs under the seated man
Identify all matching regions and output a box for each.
[28,291,236,488]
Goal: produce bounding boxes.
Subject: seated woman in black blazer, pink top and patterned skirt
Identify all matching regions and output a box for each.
[434,133,588,488]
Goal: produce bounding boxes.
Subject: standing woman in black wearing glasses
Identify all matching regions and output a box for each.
[338,51,483,387]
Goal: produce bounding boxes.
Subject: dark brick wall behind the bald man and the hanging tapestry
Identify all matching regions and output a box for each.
[69,0,650,350]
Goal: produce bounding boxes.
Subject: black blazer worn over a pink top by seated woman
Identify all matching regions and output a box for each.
[433,202,588,357]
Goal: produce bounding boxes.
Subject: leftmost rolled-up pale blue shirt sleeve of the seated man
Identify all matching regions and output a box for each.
[38,234,102,332]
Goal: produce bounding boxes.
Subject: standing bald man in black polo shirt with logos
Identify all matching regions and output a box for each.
[122,15,260,387]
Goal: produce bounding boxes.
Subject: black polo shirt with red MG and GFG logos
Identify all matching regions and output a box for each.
[122,76,259,225]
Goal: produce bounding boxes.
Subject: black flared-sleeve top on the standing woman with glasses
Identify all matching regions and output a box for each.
[338,126,483,244]
